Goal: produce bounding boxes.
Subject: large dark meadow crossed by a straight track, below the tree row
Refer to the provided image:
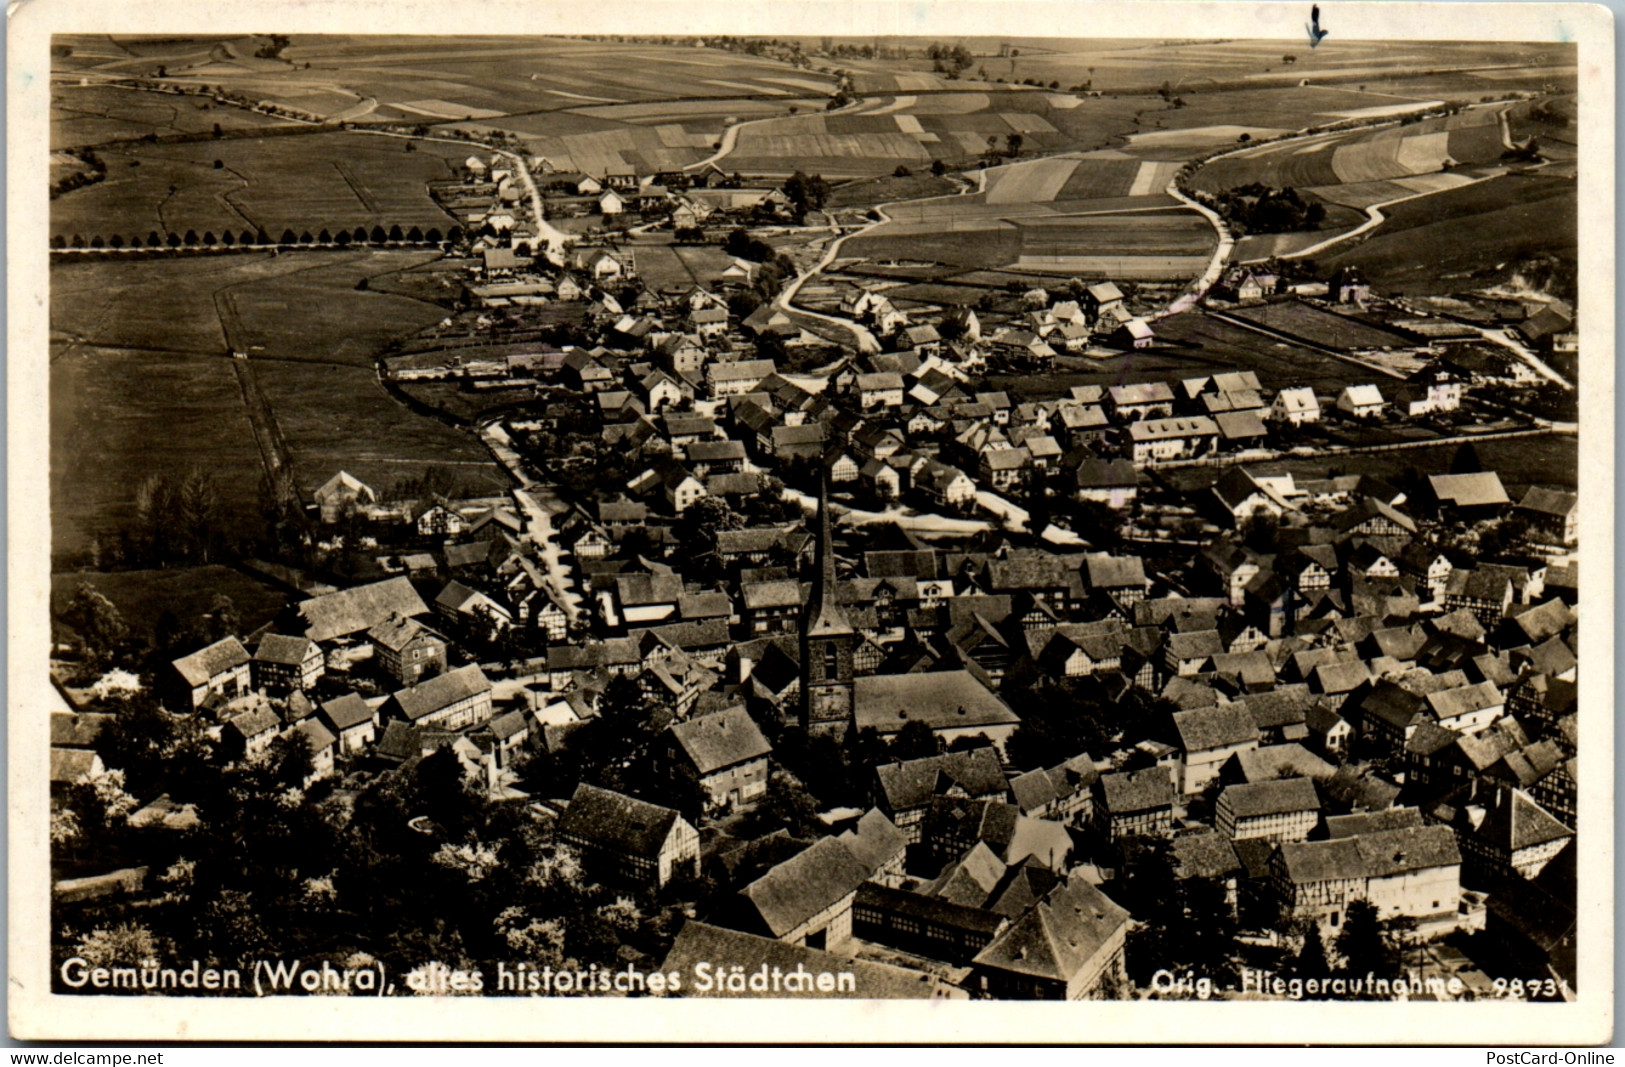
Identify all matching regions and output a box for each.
[50,252,502,559]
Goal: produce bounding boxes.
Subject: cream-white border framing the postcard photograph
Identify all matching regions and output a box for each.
[7,0,1615,1046]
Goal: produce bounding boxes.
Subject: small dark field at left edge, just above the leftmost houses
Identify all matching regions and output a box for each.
[50,567,288,637]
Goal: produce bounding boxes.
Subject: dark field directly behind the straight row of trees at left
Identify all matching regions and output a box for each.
[50,133,466,240]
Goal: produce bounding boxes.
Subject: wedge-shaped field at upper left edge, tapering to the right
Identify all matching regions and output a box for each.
[50,83,299,149]
